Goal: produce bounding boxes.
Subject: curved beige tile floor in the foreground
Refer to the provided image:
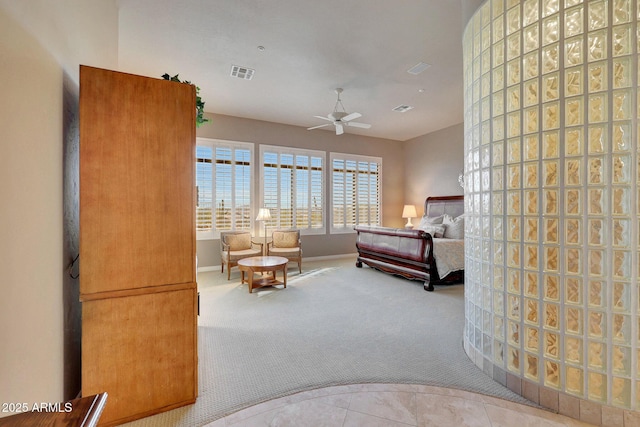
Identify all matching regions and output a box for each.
[206,384,591,427]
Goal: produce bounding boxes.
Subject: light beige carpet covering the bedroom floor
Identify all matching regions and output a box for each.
[124,258,528,427]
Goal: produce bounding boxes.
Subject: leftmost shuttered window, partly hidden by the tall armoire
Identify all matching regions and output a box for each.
[196,138,253,239]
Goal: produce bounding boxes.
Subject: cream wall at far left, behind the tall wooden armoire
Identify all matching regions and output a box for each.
[0,0,118,417]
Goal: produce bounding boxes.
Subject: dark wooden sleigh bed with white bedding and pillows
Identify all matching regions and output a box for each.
[355,196,464,291]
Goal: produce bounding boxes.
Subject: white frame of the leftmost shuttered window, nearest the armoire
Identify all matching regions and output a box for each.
[194,137,255,240]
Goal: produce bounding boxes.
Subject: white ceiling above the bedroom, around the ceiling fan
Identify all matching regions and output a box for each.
[118,0,463,141]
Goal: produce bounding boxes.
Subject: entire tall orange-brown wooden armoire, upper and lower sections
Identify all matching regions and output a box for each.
[80,66,198,425]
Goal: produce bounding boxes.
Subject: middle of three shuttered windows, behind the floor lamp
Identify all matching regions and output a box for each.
[260,145,325,234]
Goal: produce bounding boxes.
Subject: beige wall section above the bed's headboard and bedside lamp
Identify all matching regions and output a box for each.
[404,123,464,215]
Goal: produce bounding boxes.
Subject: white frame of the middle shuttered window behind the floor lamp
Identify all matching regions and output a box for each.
[258,144,327,235]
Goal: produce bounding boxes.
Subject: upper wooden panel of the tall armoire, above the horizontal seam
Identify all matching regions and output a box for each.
[80,67,195,294]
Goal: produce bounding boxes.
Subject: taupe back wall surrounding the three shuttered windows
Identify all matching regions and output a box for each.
[197,113,404,268]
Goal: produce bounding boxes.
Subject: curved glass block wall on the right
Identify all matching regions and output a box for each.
[464,0,640,410]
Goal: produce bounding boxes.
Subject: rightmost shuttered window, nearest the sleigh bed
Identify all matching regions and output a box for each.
[330,153,382,233]
